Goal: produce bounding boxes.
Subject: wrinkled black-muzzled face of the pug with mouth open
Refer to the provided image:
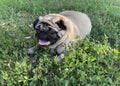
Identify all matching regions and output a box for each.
[33,17,66,46]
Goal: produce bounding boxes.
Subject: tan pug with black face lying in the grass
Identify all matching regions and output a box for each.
[28,11,92,59]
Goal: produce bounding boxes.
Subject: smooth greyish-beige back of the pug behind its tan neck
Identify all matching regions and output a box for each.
[60,11,92,39]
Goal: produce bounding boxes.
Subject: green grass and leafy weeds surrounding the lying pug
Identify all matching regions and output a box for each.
[0,0,120,86]
